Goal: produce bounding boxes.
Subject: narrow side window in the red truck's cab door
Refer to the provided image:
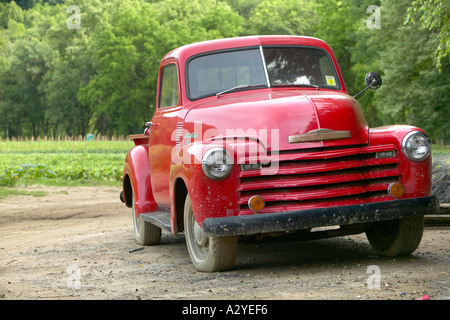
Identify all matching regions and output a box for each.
[159,64,179,108]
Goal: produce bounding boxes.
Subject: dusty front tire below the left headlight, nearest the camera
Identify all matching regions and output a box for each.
[184,194,238,272]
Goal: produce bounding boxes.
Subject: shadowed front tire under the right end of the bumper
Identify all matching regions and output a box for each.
[366,216,424,257]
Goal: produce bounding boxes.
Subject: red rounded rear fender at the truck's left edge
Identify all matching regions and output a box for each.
[123,144,157,215]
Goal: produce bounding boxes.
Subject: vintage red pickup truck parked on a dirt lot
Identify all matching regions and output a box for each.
[121,36,439,272]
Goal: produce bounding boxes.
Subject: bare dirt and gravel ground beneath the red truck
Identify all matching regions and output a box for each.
[0,187,450,300]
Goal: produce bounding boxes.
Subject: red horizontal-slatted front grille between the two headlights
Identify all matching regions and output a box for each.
[239,145,401,215]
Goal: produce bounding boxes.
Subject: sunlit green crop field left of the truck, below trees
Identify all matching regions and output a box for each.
[0,140,133,186]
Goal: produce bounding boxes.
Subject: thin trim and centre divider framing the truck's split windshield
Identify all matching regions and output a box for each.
[184,44,342,101]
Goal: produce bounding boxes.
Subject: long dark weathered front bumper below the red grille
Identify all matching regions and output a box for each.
[203,196,439,237]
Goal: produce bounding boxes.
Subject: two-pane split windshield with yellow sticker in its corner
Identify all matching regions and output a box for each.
[187,46,341,100]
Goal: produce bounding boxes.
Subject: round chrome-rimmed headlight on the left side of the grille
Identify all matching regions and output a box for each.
[202,148,233,180]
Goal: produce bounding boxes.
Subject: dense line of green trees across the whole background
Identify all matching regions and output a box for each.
[0,0,450,143]
